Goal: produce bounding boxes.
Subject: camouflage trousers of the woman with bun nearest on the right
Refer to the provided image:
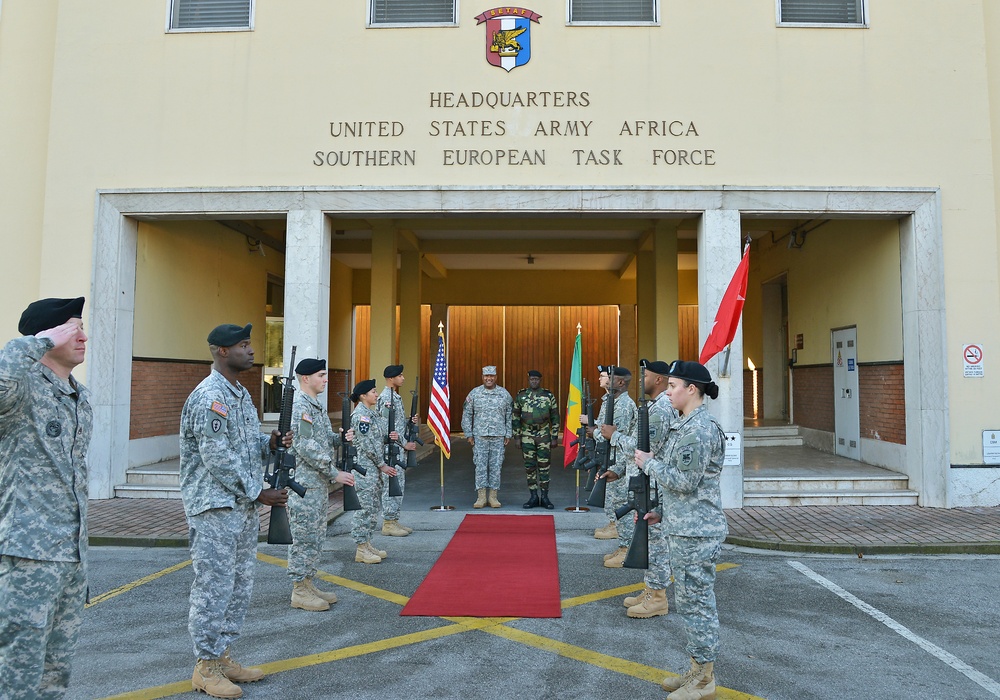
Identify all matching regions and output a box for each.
[668,535,722,664]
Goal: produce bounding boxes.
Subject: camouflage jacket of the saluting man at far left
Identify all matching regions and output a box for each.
[0,336,93,563]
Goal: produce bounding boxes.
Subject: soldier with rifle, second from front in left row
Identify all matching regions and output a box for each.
[288,358,354,611]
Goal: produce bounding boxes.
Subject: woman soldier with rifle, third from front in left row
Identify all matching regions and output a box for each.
[351,379,402,564]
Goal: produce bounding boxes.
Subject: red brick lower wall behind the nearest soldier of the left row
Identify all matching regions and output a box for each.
[128,359,263,440]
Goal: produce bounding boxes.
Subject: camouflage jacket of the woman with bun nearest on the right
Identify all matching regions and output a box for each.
[643,406,728,537]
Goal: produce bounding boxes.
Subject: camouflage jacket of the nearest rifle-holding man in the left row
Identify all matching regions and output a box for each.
[180,369,272,518]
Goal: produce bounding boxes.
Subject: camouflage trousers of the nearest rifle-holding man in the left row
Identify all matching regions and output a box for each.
[188,504,258,659]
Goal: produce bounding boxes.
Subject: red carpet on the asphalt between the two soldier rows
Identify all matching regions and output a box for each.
[400,515,562,617]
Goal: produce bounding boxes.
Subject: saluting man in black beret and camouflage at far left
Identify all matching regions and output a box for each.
[0,297,93,700]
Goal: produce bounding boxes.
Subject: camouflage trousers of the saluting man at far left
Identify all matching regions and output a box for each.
[0,555,87,700]
